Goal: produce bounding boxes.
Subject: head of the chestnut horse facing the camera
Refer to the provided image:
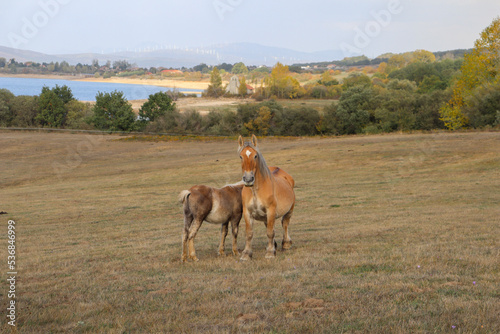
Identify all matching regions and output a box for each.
[238,135,269,187]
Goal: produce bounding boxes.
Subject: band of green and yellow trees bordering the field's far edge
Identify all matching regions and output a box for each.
[0,18,500,136]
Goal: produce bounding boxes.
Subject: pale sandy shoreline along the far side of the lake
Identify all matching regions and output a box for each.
[0,73,210,94]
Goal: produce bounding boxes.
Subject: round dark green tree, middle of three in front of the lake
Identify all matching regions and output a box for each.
[90,91,135,131]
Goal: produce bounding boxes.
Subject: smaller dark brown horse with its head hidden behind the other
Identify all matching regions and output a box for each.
[179,182,243,262]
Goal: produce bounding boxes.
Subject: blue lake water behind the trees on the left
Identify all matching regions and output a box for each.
[0,77,199,101]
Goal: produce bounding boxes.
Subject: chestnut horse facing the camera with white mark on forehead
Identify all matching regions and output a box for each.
[238,135,295,260]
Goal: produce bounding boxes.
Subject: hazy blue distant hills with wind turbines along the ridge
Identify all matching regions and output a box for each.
[0,43,343,68]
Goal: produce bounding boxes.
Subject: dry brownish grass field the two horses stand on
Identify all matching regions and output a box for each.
[0,131,500,333]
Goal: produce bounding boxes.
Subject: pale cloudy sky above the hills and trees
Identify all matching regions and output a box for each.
[0,0,500,58]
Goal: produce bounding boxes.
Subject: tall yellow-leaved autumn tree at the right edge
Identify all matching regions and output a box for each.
[440,17,500,130]
